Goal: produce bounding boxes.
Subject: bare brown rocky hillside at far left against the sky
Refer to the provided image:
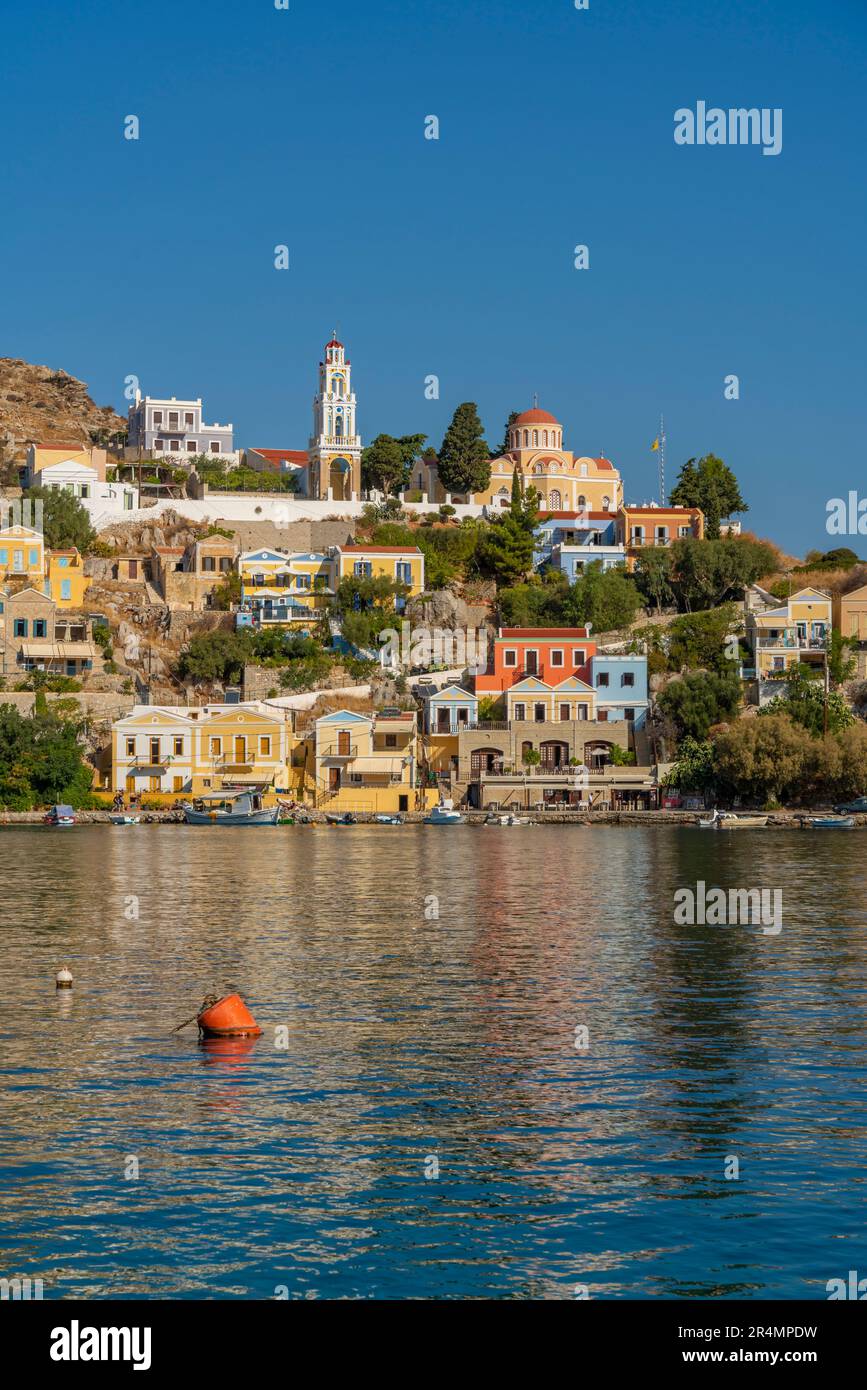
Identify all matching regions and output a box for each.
[0,357,126,457]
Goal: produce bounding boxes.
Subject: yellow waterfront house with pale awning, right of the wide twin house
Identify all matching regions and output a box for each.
[315,709,438,812]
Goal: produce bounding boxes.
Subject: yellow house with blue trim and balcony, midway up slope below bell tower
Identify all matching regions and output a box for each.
[238,548,332,627]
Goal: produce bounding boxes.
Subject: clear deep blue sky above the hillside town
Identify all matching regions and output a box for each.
[0,0,867,553]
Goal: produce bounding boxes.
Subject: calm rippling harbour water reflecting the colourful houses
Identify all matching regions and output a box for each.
[0,826,867,1298]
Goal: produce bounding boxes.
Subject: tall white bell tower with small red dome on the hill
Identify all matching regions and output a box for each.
[307,332,361,502]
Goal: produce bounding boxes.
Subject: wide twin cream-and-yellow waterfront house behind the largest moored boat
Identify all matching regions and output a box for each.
[111,701,300,795]
